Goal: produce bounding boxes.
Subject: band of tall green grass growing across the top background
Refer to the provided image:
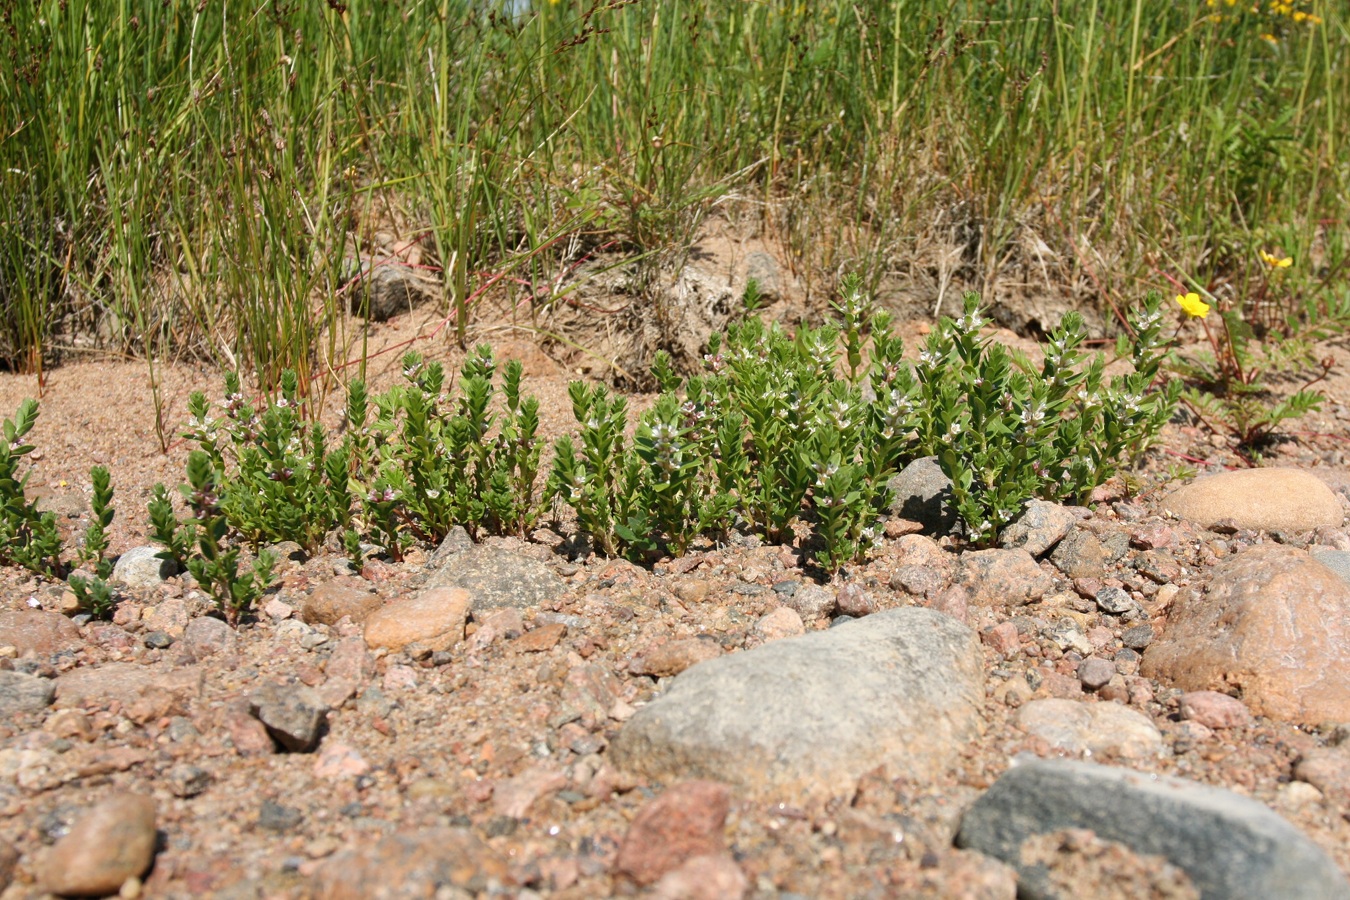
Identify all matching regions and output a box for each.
[0,0,1350,383]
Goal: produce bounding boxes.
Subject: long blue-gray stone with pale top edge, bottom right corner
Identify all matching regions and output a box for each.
[957,760,1350,900]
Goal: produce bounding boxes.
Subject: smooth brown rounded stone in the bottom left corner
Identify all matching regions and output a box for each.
[41,793,155,897]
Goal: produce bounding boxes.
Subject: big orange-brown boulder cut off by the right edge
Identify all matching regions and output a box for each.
[1142,546,1350,725]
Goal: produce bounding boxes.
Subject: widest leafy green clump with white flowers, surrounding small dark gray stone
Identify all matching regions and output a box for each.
[548,278,1179,572]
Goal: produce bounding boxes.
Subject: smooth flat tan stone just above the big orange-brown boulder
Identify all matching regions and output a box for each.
[1162,468,1345,534]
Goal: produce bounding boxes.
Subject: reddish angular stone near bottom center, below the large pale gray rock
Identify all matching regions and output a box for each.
[616,780,732,885]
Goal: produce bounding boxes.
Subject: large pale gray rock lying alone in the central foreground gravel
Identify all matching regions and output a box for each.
[610,607,984,800]
